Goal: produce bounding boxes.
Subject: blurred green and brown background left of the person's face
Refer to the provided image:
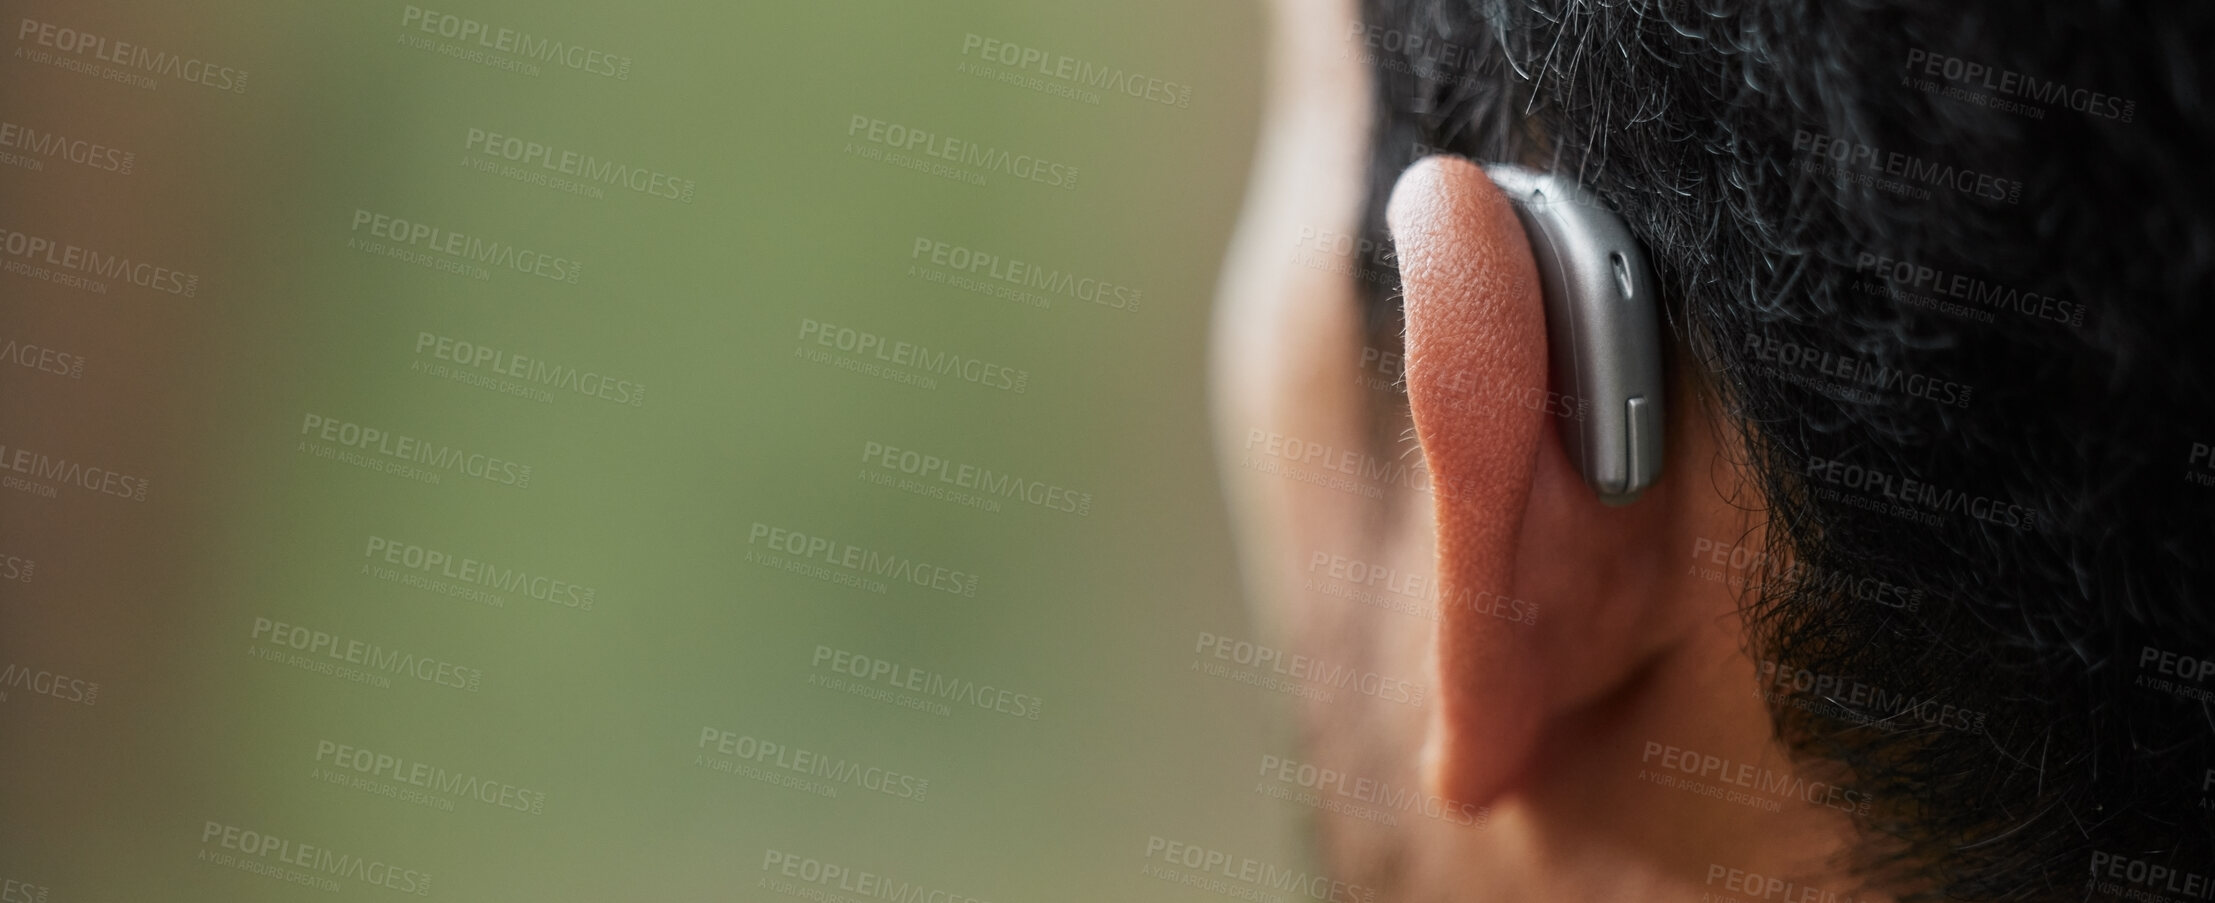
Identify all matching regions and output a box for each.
[0,0,1311,903]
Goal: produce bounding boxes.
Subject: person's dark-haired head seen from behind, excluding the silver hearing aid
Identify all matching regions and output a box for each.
[1214,0,2215,901]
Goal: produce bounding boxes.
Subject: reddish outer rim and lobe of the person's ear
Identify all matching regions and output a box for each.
[1387,157,1551,806]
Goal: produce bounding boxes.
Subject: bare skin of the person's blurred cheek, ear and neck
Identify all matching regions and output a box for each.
[1212,0,1874,901]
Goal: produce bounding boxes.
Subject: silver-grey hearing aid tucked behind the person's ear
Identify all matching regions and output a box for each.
[1484,164,1661,505]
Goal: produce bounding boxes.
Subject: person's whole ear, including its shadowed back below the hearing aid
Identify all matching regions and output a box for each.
[1387,157,1686,806]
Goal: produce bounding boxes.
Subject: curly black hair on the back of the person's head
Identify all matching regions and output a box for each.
[1347,0,2215,901]
